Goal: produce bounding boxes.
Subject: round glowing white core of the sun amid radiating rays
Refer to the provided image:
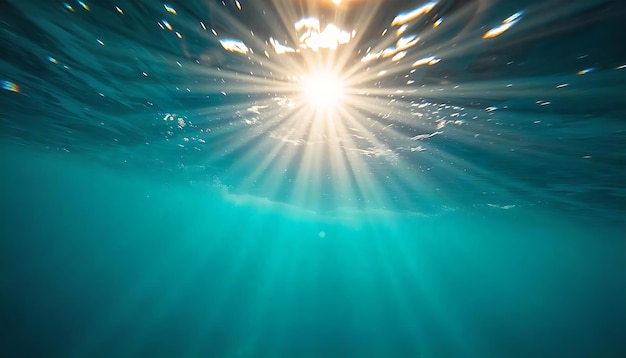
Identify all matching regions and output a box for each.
[300,72,344,111]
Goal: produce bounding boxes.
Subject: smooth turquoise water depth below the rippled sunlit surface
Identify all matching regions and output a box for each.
[2,147,626,357]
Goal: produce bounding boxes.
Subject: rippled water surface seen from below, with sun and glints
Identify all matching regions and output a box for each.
[0,0,626,213]
